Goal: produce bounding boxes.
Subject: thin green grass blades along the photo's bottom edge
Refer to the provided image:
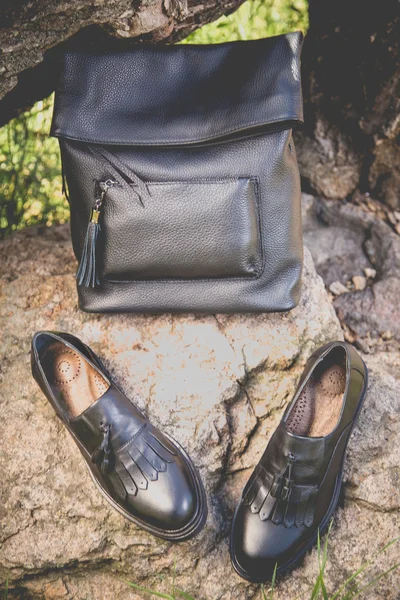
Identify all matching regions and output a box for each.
[126,523,400,600]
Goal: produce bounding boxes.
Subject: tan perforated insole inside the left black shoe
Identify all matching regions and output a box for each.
[41,341,109,417]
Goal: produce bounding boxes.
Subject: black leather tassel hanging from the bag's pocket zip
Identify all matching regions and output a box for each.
[76,179,116,288]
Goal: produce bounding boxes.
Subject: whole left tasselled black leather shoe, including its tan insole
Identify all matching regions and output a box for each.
[32,331,207,541]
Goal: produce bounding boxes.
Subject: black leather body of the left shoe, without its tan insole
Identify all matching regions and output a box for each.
[32,332,206,540]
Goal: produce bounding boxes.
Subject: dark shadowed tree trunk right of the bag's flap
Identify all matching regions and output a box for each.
[297,0,400,208]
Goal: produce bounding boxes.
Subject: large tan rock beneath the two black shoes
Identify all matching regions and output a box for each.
[0,227,400,600]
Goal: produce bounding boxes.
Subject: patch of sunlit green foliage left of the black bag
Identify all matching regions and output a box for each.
[0,97,69,239]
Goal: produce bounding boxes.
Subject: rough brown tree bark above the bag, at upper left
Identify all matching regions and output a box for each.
[0,0,243,126]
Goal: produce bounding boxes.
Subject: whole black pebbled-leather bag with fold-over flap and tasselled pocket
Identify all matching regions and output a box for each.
[52,33,303,313]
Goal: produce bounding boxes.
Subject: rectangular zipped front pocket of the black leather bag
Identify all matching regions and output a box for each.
[98,177,262,282]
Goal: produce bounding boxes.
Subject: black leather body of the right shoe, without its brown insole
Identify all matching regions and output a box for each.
[231,342,366,581]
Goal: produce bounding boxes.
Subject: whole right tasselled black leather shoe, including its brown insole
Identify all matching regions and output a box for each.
[230,342,367,582]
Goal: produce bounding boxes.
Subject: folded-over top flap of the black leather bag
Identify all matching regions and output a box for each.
[51,32,303,145]
